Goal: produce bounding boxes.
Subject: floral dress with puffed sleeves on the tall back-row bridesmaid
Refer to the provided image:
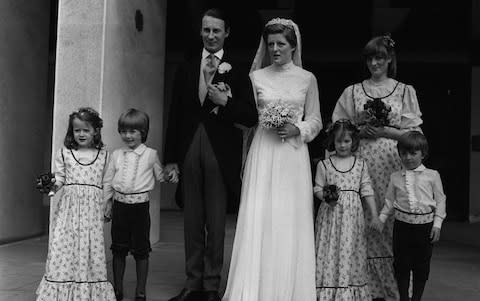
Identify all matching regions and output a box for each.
[332,79,422,300]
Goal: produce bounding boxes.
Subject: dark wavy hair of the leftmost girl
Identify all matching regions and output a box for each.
[63,107,104,149]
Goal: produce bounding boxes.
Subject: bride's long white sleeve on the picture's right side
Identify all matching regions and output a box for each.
[295,74,322,146]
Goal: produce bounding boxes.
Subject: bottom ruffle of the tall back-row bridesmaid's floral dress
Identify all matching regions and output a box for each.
[367,257,400,300]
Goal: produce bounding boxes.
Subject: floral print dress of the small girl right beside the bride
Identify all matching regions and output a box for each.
[314,157,373,301]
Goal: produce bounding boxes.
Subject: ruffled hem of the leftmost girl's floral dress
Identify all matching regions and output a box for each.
[37,278,117,301]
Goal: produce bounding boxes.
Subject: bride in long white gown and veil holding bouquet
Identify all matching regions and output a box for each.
[223,18,322,301]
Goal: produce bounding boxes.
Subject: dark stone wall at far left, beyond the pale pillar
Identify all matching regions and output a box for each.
[0,0,52,243]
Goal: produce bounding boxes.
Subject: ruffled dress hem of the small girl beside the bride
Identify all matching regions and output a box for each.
[317,285,371,301]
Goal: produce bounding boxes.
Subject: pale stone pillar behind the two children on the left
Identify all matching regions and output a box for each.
[52,0,166,253]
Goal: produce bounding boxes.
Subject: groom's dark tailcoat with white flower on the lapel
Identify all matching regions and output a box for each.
[164,50,258,212]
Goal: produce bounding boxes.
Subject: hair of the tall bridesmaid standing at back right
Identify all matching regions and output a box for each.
[363,34,397,78]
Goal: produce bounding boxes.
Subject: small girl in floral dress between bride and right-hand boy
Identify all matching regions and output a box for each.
[314,119,381,301]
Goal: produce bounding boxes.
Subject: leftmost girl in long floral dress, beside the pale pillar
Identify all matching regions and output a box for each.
[37,108,116,301]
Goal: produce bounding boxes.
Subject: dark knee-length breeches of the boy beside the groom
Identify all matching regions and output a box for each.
[110,200,152,259]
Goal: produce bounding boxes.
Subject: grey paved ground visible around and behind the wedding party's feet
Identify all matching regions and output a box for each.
[0,211,480,301]
